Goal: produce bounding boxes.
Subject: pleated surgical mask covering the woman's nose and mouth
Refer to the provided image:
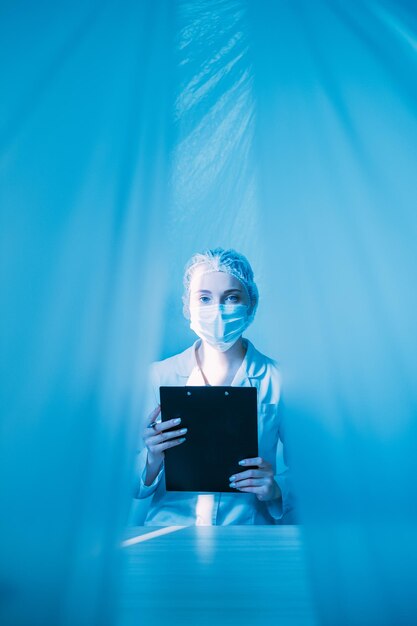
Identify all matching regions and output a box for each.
[190,304,249,352]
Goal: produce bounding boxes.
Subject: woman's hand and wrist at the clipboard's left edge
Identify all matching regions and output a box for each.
[143,404,187,485]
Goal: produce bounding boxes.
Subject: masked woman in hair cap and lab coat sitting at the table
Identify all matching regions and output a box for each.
[135,248,291,526]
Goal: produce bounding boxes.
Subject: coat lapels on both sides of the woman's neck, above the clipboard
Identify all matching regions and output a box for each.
[176,339,266,386]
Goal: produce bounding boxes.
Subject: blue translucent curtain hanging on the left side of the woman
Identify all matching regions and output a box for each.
[0,0,174,626]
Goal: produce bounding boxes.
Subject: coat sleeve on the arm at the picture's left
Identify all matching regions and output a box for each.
[133,363,164,499]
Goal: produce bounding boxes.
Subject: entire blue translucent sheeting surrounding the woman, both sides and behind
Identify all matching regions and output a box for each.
[0,0,417,626]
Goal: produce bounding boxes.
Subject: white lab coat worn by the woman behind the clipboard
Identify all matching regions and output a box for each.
[134,339,292,526]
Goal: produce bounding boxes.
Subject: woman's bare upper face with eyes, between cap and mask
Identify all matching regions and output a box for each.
[190,267,249,306]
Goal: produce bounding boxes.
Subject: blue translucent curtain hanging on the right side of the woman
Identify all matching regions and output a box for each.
[249,0,417,625]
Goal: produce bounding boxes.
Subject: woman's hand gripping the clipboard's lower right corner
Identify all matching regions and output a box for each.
[229,456,281,501]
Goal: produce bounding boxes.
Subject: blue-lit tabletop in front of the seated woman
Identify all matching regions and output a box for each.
[119,526,317,626]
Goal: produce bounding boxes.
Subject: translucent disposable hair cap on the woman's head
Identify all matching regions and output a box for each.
[182,248,259,321]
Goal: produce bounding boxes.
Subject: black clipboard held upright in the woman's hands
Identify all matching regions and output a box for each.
[160,386,258,493]
